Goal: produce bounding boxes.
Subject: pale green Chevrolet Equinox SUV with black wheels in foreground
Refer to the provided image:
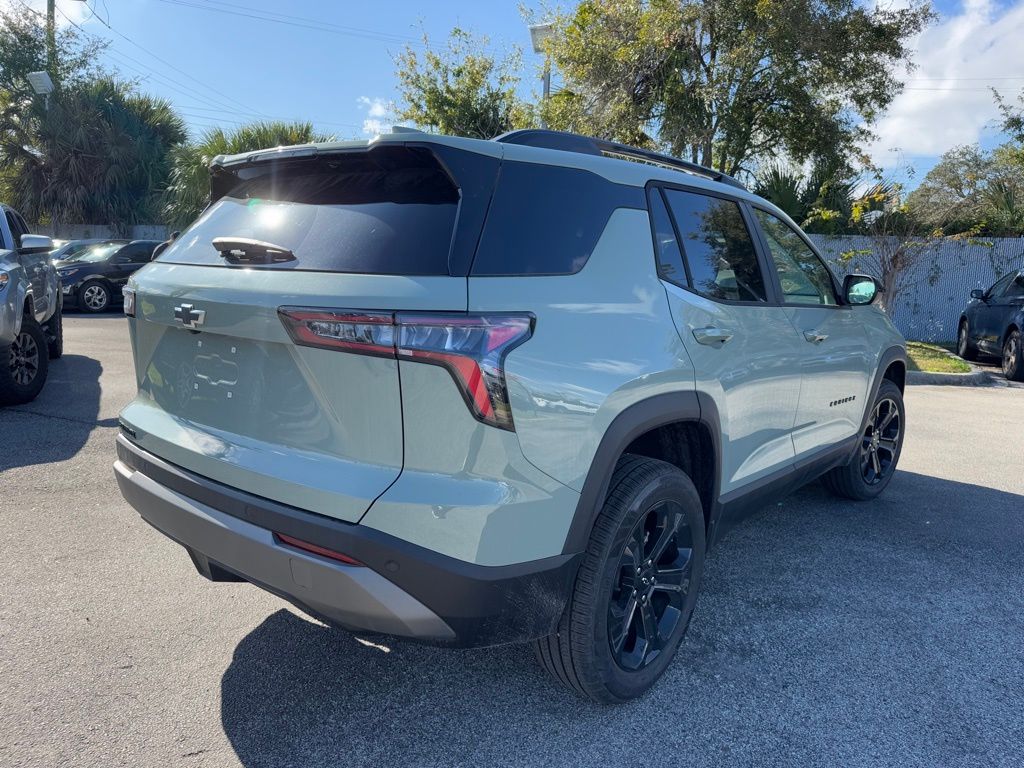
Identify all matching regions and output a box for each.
[115,130,905,702]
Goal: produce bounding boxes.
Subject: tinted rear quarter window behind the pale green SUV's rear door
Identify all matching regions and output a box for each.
[472,163,647,274]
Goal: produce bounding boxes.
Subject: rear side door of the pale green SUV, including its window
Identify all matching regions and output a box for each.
[649,187,802,495]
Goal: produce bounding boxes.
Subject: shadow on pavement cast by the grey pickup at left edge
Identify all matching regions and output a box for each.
[0,354,106,472]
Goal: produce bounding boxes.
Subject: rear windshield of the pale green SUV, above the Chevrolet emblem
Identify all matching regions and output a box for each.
[157,146,459,274]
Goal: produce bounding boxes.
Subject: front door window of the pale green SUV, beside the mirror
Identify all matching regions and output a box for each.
[754,209,839,305]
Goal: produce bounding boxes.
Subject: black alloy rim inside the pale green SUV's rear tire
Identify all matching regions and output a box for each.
[608,501,693,672]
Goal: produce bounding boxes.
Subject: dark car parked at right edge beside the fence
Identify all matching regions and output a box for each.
[956,269,1024,381]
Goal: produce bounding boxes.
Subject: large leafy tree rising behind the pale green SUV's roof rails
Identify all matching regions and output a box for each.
[543,0,933,174]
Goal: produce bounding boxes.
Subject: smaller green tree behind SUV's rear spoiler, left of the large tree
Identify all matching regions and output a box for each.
[395,28,534,138]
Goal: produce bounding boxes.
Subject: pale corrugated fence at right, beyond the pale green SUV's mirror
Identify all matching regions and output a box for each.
[811,234,1024,341]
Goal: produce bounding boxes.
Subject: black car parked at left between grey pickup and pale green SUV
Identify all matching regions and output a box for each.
[56,240,160,312]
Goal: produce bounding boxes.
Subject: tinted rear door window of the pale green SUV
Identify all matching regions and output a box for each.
[665,189,767,301]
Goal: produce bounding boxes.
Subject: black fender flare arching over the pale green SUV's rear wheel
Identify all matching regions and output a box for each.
[562,390,722,554]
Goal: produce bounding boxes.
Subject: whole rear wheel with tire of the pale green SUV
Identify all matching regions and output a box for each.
[534,455,706,703]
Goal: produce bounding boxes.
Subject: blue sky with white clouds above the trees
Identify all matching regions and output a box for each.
[12,0,1024,185]
